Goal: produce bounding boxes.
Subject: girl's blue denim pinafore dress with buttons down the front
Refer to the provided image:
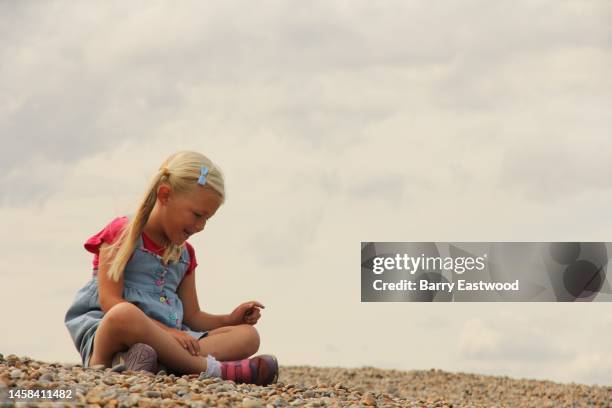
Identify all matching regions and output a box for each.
[64,235,207,367]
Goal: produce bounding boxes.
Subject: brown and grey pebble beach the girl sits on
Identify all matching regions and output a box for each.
[0,354,612,408]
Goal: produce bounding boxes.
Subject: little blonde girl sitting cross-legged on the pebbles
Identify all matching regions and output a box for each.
[65,151,278,385]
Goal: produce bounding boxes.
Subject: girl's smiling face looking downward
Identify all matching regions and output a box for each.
[158,185,221,245]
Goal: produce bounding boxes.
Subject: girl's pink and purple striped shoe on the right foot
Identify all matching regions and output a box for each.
[220,354,278,385]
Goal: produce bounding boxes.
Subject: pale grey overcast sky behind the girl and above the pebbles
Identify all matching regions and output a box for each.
[0,0,612,385]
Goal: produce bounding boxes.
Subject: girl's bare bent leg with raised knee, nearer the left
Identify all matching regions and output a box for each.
[90,302,206,374]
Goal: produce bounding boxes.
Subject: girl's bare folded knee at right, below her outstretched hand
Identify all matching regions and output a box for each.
[198,324,259,361]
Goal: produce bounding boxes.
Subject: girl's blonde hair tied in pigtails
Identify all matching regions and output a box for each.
[107,151,225,282]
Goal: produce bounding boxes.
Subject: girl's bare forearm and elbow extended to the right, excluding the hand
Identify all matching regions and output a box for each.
[178,272,231,331]
